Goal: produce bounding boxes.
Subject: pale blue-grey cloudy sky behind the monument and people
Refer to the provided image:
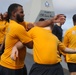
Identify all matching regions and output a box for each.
[0,0,76,34]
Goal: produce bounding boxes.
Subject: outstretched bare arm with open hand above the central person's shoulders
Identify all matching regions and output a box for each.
[26,15,60,31]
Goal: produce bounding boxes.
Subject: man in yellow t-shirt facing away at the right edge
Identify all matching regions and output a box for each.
[63,14,76,75]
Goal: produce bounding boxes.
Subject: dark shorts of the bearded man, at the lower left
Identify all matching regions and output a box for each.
[0,66,27,75]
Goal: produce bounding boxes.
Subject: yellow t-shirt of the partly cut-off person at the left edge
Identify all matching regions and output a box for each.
[0,21,8,44]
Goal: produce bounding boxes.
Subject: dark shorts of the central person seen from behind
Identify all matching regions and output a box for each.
[29,63,64,75]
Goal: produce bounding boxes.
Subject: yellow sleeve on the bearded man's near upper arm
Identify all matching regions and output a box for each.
[16,25,32,44]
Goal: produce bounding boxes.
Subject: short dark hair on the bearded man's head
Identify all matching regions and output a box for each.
[7,3,22,20]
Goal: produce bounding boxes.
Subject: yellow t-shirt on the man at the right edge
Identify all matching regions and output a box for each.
[63,26,76,63]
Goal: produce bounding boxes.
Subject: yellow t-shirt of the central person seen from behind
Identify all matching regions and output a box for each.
[28,26,65,64]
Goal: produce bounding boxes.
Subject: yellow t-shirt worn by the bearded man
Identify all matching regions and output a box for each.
[0,20,31,69]
